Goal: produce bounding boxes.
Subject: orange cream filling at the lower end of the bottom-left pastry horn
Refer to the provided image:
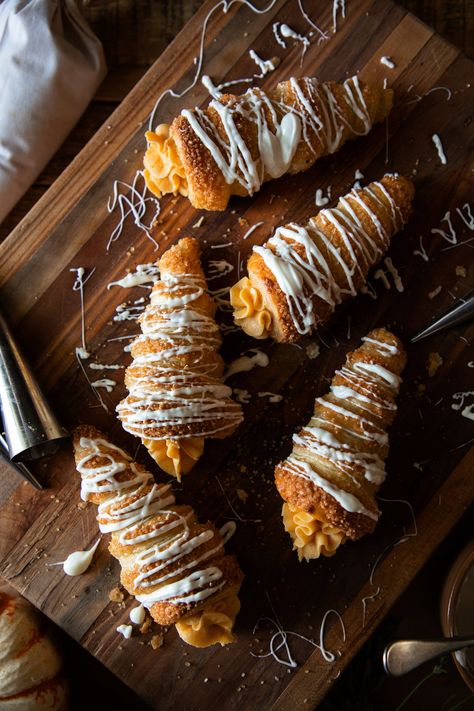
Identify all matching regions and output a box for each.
[176,591,240,647]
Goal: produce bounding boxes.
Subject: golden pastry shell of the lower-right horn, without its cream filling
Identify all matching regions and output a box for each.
[275,329,406,542]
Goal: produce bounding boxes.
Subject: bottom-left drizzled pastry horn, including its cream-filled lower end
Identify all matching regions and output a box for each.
[74,427,243,647]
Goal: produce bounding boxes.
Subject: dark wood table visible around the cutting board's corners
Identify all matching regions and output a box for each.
[0,0,474,711]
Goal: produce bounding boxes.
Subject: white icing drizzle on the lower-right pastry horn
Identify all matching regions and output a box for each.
[283,330,401,520]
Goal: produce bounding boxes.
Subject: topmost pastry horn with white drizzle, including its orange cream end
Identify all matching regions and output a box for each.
[144,77,393,210]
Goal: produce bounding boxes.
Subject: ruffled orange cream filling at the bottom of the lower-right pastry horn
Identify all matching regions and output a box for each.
[281,503,346,561]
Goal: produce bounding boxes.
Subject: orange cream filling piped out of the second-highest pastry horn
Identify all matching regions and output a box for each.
[230,277,273,338]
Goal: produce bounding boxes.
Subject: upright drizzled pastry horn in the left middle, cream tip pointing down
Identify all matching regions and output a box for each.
[117,237,242,480]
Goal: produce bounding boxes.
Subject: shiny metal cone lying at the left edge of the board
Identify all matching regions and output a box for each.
[0,313,68,463]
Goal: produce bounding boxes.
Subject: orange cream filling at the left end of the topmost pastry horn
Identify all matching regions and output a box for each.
[143,123,188,197]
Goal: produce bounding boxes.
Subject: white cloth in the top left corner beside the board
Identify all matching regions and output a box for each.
[0,0,106,222]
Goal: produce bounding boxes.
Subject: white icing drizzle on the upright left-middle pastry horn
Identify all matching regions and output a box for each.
[116,272,242,440]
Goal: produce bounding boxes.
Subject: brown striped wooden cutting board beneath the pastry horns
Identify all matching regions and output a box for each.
[0,0,474,710]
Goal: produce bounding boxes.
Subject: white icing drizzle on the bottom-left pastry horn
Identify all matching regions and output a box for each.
[76,437,225,608]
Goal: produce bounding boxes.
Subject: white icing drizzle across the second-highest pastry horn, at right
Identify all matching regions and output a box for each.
[253,177,402,335]
